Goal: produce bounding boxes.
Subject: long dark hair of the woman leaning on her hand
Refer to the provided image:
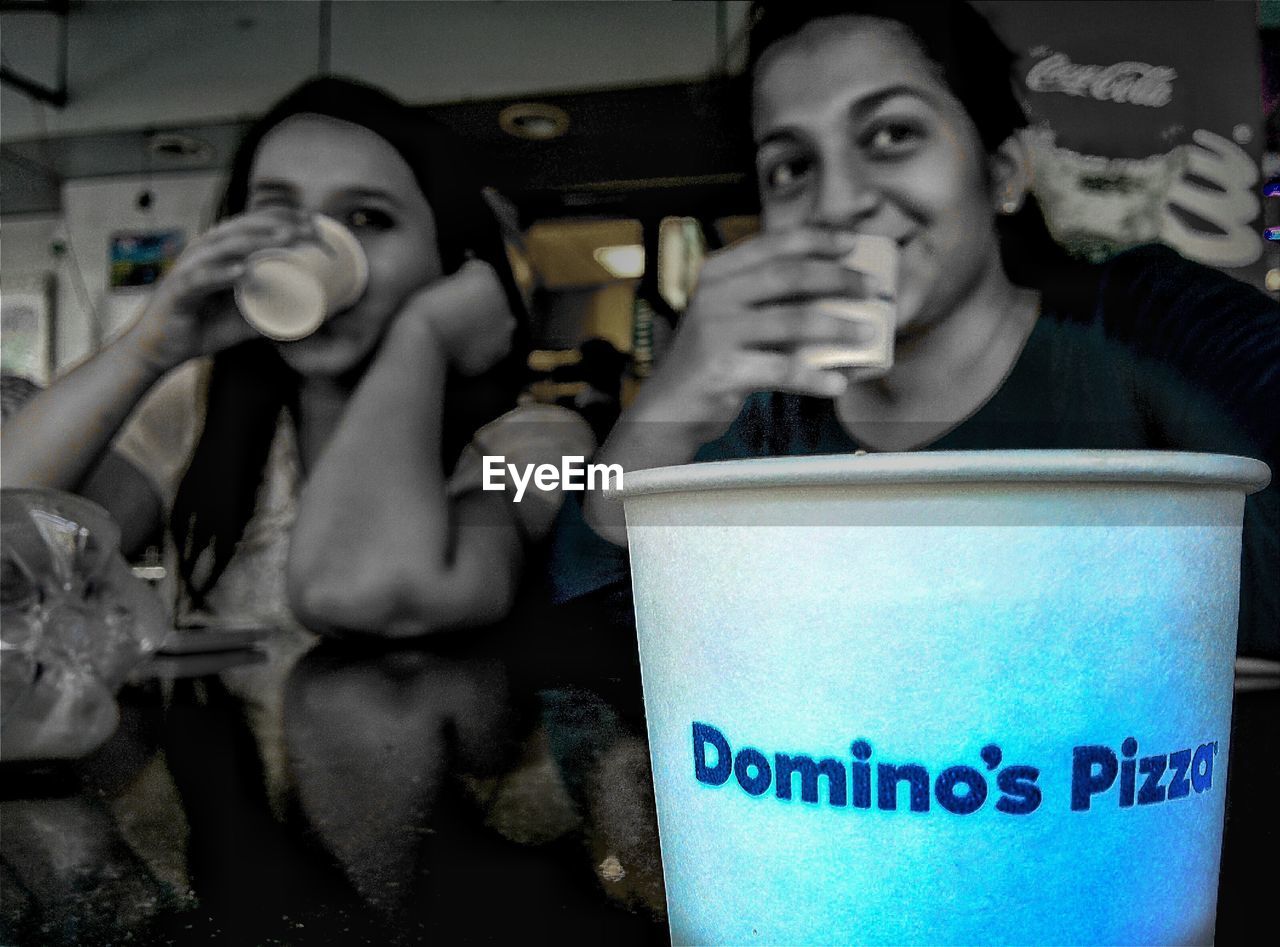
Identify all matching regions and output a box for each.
[172,77,529,604]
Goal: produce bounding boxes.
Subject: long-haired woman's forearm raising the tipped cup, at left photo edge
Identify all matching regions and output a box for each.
[0,331,164,491]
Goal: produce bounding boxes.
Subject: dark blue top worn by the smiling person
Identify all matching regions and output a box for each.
[552,246,1280,657]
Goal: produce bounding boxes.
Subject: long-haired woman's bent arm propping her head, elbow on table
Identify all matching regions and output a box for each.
[288,262,524,637]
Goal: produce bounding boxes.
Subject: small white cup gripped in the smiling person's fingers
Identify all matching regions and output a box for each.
[803,234,899,374]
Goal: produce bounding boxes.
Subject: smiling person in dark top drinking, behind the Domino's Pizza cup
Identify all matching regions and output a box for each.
[556,1,1280,916]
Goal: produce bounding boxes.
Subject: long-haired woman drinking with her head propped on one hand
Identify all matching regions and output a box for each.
[4,71,591,636]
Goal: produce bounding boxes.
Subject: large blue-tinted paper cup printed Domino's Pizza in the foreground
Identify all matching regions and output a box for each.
[625,452,1270,944]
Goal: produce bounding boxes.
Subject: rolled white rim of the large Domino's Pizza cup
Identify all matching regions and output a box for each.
[621,450,1271,499]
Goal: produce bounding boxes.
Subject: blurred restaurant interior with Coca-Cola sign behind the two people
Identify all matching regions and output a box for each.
[0,0,1280,406]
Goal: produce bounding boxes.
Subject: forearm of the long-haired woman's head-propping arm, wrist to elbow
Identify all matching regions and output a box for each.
[288,312,494,631]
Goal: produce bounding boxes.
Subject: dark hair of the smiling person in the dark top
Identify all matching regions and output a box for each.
[748,0,1074,289]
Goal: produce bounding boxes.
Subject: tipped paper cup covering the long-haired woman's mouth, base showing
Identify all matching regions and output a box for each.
[236,214,369,342]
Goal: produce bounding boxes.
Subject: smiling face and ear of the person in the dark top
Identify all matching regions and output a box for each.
[754,18,1028,340]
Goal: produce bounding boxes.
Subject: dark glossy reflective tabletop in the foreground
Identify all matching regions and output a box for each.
[0,632,1280,944]
